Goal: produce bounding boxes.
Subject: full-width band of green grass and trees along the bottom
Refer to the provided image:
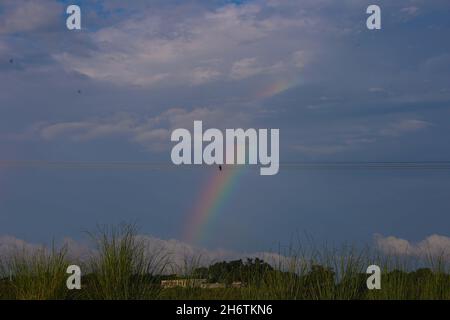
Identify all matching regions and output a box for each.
[0,226,450,300]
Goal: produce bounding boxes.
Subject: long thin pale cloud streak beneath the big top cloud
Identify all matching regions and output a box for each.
[24,108,248,151]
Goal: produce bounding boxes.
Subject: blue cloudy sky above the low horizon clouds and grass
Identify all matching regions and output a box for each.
[0,0,450,258]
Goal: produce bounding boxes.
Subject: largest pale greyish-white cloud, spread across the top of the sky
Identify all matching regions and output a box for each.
[53,3,318,87]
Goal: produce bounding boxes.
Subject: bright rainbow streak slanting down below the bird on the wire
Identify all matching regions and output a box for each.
[184,165,243,244]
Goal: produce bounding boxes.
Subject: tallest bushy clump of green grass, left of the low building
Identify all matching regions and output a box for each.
[86,225,168,300]
